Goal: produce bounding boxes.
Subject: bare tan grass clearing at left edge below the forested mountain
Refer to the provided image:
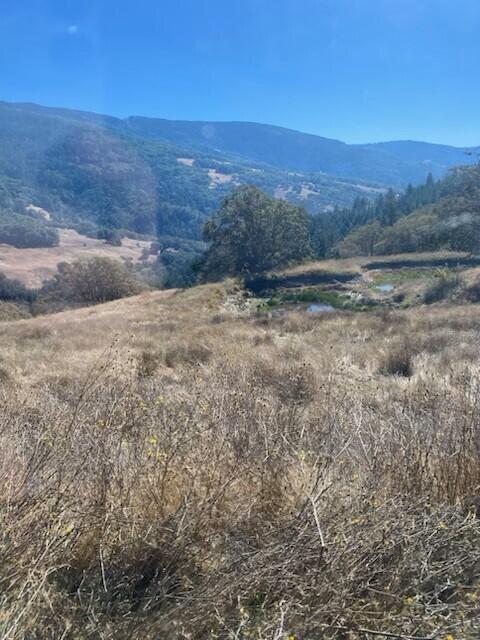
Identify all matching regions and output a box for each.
[0,229,150,287]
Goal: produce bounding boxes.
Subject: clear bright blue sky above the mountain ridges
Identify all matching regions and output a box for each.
[0,0,480,146]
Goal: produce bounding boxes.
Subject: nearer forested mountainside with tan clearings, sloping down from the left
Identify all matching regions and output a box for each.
[0,103,388,238]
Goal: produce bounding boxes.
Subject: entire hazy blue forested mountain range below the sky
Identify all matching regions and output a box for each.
[0,102,476,246]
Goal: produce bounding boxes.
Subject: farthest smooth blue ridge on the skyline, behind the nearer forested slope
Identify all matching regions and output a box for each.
[127,117,480,186]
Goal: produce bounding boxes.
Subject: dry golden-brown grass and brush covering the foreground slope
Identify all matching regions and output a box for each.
[0,284,480,640]
